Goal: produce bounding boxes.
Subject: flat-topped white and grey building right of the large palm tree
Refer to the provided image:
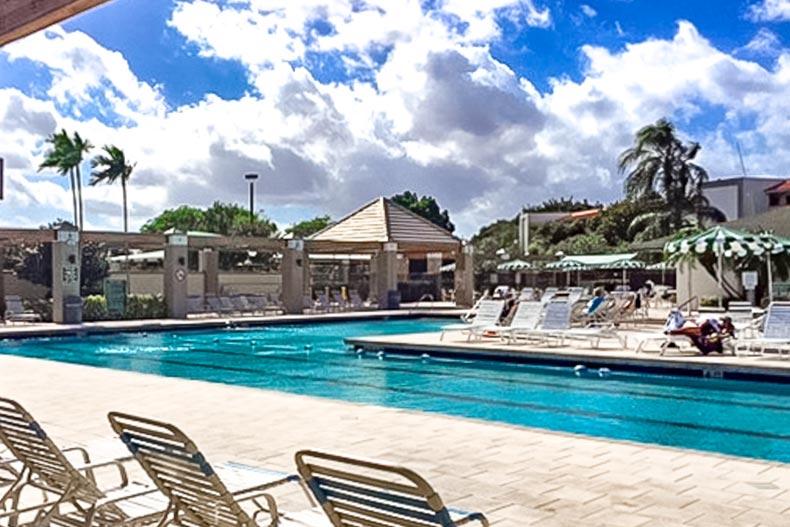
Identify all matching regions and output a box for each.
[702,176,790,221]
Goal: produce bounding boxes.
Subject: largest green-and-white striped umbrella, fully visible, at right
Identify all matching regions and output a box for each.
[664,225,767,307]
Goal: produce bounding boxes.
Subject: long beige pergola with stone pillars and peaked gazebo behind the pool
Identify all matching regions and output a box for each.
[0,198,474,322]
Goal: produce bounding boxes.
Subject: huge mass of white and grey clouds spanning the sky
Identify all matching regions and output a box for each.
[0,6,790,235]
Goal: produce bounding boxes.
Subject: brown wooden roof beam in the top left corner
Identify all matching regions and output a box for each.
[0,0,112,46]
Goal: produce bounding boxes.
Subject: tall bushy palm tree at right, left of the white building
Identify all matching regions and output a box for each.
[618,119,724,236]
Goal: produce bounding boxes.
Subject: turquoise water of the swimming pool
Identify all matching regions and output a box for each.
[0,319,790,462]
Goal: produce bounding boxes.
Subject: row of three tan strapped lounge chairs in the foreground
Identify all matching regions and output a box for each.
[0,398,488,527]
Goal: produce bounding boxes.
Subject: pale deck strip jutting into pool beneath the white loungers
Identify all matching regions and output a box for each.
[346,326,790,382]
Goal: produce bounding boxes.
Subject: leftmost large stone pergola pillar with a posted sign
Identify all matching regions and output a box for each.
[52,227,82,324]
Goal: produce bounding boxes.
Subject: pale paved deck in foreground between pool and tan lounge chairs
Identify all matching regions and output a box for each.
[0,356,790,527]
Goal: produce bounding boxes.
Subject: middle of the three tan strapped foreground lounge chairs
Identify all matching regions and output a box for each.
[108,412,309,527]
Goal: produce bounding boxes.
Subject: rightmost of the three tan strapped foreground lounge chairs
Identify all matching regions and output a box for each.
[296,450,488,527]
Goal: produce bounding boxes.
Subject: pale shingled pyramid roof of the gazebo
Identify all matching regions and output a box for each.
[309,198,460,244]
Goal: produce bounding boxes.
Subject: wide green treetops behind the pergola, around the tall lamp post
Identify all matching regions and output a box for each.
[140,201,277,237]
